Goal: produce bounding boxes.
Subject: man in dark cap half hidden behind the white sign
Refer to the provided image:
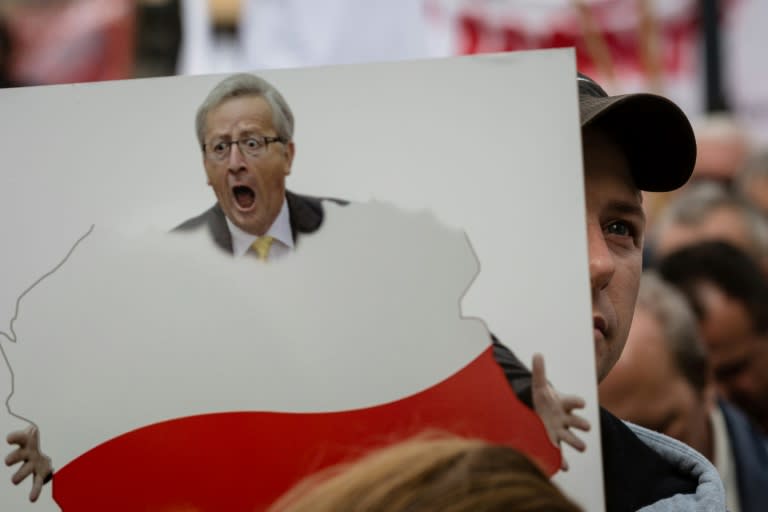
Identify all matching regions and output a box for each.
[496,75,725,512]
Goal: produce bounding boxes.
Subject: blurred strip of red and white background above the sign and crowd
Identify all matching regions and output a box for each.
[0,0,768,142]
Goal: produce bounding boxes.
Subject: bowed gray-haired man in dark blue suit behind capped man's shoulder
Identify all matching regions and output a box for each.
[599,272,768,512]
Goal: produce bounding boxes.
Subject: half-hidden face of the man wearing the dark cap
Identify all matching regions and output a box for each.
[583,129,645,381]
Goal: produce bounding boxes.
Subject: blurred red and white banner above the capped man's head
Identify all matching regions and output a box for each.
[427,0,744,96]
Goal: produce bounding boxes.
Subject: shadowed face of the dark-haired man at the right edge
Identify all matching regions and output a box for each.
[696,282,768,423]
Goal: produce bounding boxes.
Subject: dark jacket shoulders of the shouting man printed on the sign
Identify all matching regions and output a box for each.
[173,190,346,254]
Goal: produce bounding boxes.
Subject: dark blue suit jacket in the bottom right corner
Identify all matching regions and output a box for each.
[718,401,768,512]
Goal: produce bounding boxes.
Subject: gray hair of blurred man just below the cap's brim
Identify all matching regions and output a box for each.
[654,181,768,258]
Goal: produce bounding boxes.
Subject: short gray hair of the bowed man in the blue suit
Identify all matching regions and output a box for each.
[636,271,709,393]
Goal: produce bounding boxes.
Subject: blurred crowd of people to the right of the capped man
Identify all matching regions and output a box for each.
[599,126,768,510]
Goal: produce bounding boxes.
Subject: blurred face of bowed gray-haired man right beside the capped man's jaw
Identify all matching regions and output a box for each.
[599,307,714,454]
